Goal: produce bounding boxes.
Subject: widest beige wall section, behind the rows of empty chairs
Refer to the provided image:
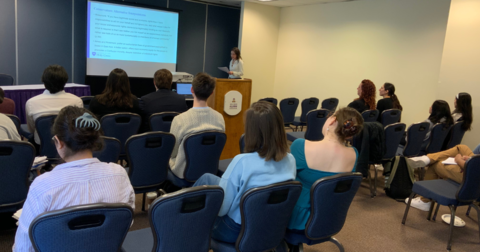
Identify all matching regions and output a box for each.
[272,0,450,124]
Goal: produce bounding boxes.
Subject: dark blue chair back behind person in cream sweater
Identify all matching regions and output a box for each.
[183,131,227,182]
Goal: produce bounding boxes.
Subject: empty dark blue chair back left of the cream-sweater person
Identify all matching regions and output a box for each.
[125,131,175,191]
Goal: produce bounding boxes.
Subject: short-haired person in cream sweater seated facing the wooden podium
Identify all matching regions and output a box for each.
[170,73,225,178]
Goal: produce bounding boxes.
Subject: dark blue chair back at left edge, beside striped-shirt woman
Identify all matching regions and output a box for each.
[0,140,35,212]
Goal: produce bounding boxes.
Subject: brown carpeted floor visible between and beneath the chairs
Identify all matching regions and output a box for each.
[0,173,480,252]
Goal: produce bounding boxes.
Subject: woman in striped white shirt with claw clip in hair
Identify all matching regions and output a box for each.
[13,106,135,252]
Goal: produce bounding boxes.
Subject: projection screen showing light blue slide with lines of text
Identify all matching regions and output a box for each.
[87,1,179,77]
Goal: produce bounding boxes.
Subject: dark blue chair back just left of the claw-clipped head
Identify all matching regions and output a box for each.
[35,114,59,158]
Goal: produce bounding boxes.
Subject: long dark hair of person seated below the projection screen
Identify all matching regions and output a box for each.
[97,68,137,108]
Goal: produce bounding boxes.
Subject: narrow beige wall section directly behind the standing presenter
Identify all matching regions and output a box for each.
[239,2,280,102]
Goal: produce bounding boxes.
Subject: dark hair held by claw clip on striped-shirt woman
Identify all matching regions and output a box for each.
[52,106,103,156]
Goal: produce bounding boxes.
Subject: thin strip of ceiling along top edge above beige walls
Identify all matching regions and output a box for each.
[192,0,355,7]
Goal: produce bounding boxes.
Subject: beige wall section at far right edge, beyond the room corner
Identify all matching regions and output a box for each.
[436,0,480,148]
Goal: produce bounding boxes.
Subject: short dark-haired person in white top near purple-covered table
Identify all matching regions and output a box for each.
[25,65,83,144]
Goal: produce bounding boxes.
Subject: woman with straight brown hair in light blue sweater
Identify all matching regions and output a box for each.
[194,101,296,243]
